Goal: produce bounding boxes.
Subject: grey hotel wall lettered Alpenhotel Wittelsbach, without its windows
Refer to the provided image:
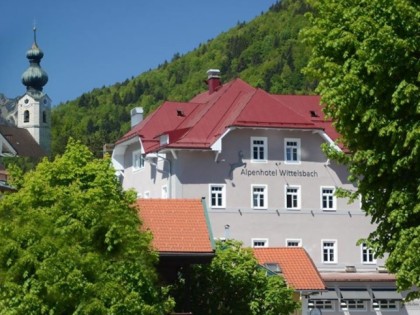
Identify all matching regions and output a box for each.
[119,123,420,315]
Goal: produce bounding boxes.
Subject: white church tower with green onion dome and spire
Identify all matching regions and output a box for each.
[17,28,51,154]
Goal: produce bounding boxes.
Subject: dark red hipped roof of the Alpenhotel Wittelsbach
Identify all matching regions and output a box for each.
[117,79,339,153]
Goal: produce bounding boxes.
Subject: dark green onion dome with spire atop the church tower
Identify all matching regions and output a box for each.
[22,28,48,94]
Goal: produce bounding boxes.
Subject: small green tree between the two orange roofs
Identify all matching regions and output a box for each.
[172,240,299,315]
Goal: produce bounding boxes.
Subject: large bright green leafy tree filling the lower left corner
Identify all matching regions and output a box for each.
[0,140,173,315]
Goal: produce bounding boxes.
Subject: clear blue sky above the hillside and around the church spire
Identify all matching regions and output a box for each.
[0,0,276,105]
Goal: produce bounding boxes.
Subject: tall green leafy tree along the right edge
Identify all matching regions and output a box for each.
[303,0,420,298]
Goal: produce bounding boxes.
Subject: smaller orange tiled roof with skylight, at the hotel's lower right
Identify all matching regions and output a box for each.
[254,247,325,290]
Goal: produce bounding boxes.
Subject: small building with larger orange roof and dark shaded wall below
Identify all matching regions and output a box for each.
[137,199,215,282]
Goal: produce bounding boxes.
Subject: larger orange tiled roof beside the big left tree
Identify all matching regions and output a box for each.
[137,199,213,253]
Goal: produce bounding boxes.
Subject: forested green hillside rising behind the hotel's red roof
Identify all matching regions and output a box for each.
[52,0,314,156]
